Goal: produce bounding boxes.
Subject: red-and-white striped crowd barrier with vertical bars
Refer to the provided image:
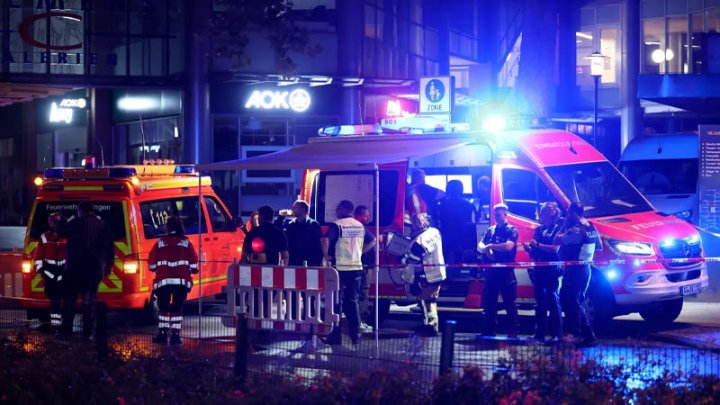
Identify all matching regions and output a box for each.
[223,263,340,336]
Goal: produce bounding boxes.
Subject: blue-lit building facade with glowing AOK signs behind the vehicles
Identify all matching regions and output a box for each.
[0,0,720,224]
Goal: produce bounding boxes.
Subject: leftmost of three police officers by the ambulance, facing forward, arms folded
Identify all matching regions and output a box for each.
[477,203,518,337]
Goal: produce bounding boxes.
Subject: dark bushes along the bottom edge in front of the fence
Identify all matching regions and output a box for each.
[0,335,720,405]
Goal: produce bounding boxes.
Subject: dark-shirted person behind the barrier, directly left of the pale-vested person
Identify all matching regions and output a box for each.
[285,200,322,266]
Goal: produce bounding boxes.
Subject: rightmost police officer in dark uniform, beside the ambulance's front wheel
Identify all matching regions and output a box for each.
[554,202,602,345]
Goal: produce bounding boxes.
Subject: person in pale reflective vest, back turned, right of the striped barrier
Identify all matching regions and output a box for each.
[321,200,365,345]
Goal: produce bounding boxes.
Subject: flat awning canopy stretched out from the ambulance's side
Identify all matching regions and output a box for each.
[196,135,475,171]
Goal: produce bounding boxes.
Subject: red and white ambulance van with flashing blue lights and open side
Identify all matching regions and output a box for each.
[298,122,708,326]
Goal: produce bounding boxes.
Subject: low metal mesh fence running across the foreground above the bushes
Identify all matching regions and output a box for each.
[0,299,720,387]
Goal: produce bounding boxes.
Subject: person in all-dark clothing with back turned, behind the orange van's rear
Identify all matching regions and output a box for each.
[58,201,115,337]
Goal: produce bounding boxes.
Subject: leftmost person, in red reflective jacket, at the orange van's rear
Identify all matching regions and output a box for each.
[35,212,66,332]
